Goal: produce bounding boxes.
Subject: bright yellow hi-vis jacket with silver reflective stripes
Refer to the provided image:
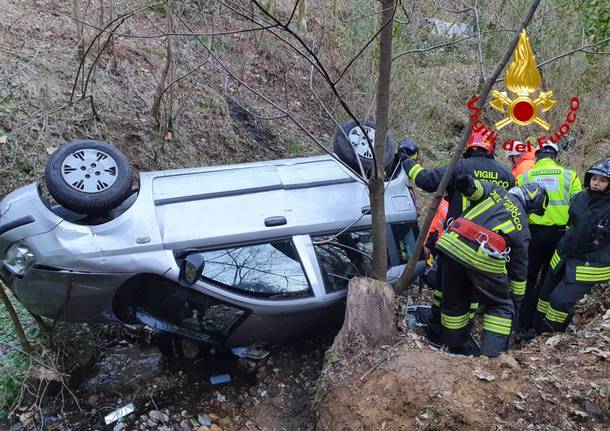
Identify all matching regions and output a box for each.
[517,158,582,226]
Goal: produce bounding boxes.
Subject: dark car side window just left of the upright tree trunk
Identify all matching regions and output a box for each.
[312,231,373,292]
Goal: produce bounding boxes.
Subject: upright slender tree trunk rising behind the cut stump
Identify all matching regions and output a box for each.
[369,0,395,281]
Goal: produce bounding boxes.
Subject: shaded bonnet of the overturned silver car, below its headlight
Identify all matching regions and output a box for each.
[0,266,134,323]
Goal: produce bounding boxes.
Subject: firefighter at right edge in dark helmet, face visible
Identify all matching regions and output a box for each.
[534,158,610,332]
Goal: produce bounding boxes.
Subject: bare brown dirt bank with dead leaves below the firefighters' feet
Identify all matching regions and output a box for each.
[317,287,610,431]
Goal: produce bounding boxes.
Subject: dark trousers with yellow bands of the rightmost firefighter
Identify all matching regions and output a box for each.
[533,264,594,332]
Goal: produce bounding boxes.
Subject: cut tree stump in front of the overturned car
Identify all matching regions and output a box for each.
[332,278,396,352]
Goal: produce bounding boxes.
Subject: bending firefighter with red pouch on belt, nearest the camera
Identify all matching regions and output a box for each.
[436,176,548,357]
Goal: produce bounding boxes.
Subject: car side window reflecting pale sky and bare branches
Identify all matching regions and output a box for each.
[201,240,312,299]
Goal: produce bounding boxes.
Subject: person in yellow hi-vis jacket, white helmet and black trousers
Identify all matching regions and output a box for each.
[517,143,582,338]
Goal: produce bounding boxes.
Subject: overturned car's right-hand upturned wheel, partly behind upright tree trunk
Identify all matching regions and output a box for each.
[333,120,394,172]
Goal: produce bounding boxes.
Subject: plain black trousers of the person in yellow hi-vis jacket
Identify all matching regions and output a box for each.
[517,225,565,330]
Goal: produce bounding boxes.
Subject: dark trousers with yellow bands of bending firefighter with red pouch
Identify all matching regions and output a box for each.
[440,255,514,358]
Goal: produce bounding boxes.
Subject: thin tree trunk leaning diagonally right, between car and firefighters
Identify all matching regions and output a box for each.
[396,0,540,294]
